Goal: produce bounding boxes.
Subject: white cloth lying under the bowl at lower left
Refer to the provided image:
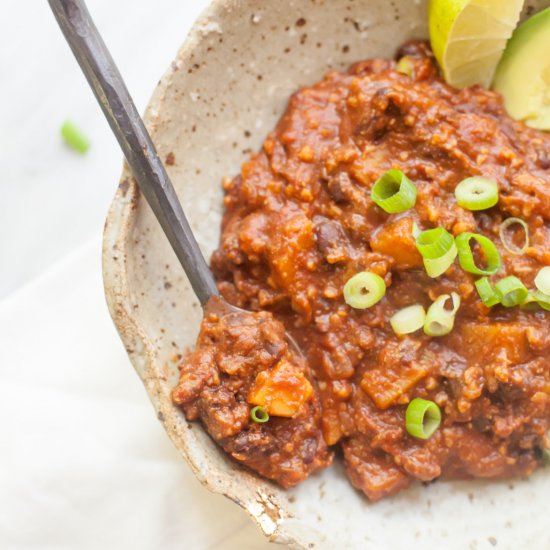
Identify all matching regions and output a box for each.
[0,237,272,550]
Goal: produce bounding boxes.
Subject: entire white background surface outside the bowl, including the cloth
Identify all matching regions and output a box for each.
[0,0,274,550]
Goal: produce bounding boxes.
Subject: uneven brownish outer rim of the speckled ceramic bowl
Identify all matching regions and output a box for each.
[102,0,300,549]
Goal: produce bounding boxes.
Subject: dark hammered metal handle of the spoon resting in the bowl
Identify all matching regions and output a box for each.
[48,0,218,305]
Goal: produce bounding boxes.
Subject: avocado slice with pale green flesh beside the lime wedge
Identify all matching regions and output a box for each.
[493,8,550,130]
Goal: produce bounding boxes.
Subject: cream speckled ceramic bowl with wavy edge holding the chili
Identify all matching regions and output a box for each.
[104,0,550,550]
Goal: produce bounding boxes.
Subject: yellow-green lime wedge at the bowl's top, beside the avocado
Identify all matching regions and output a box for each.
[429,0,524,88]
